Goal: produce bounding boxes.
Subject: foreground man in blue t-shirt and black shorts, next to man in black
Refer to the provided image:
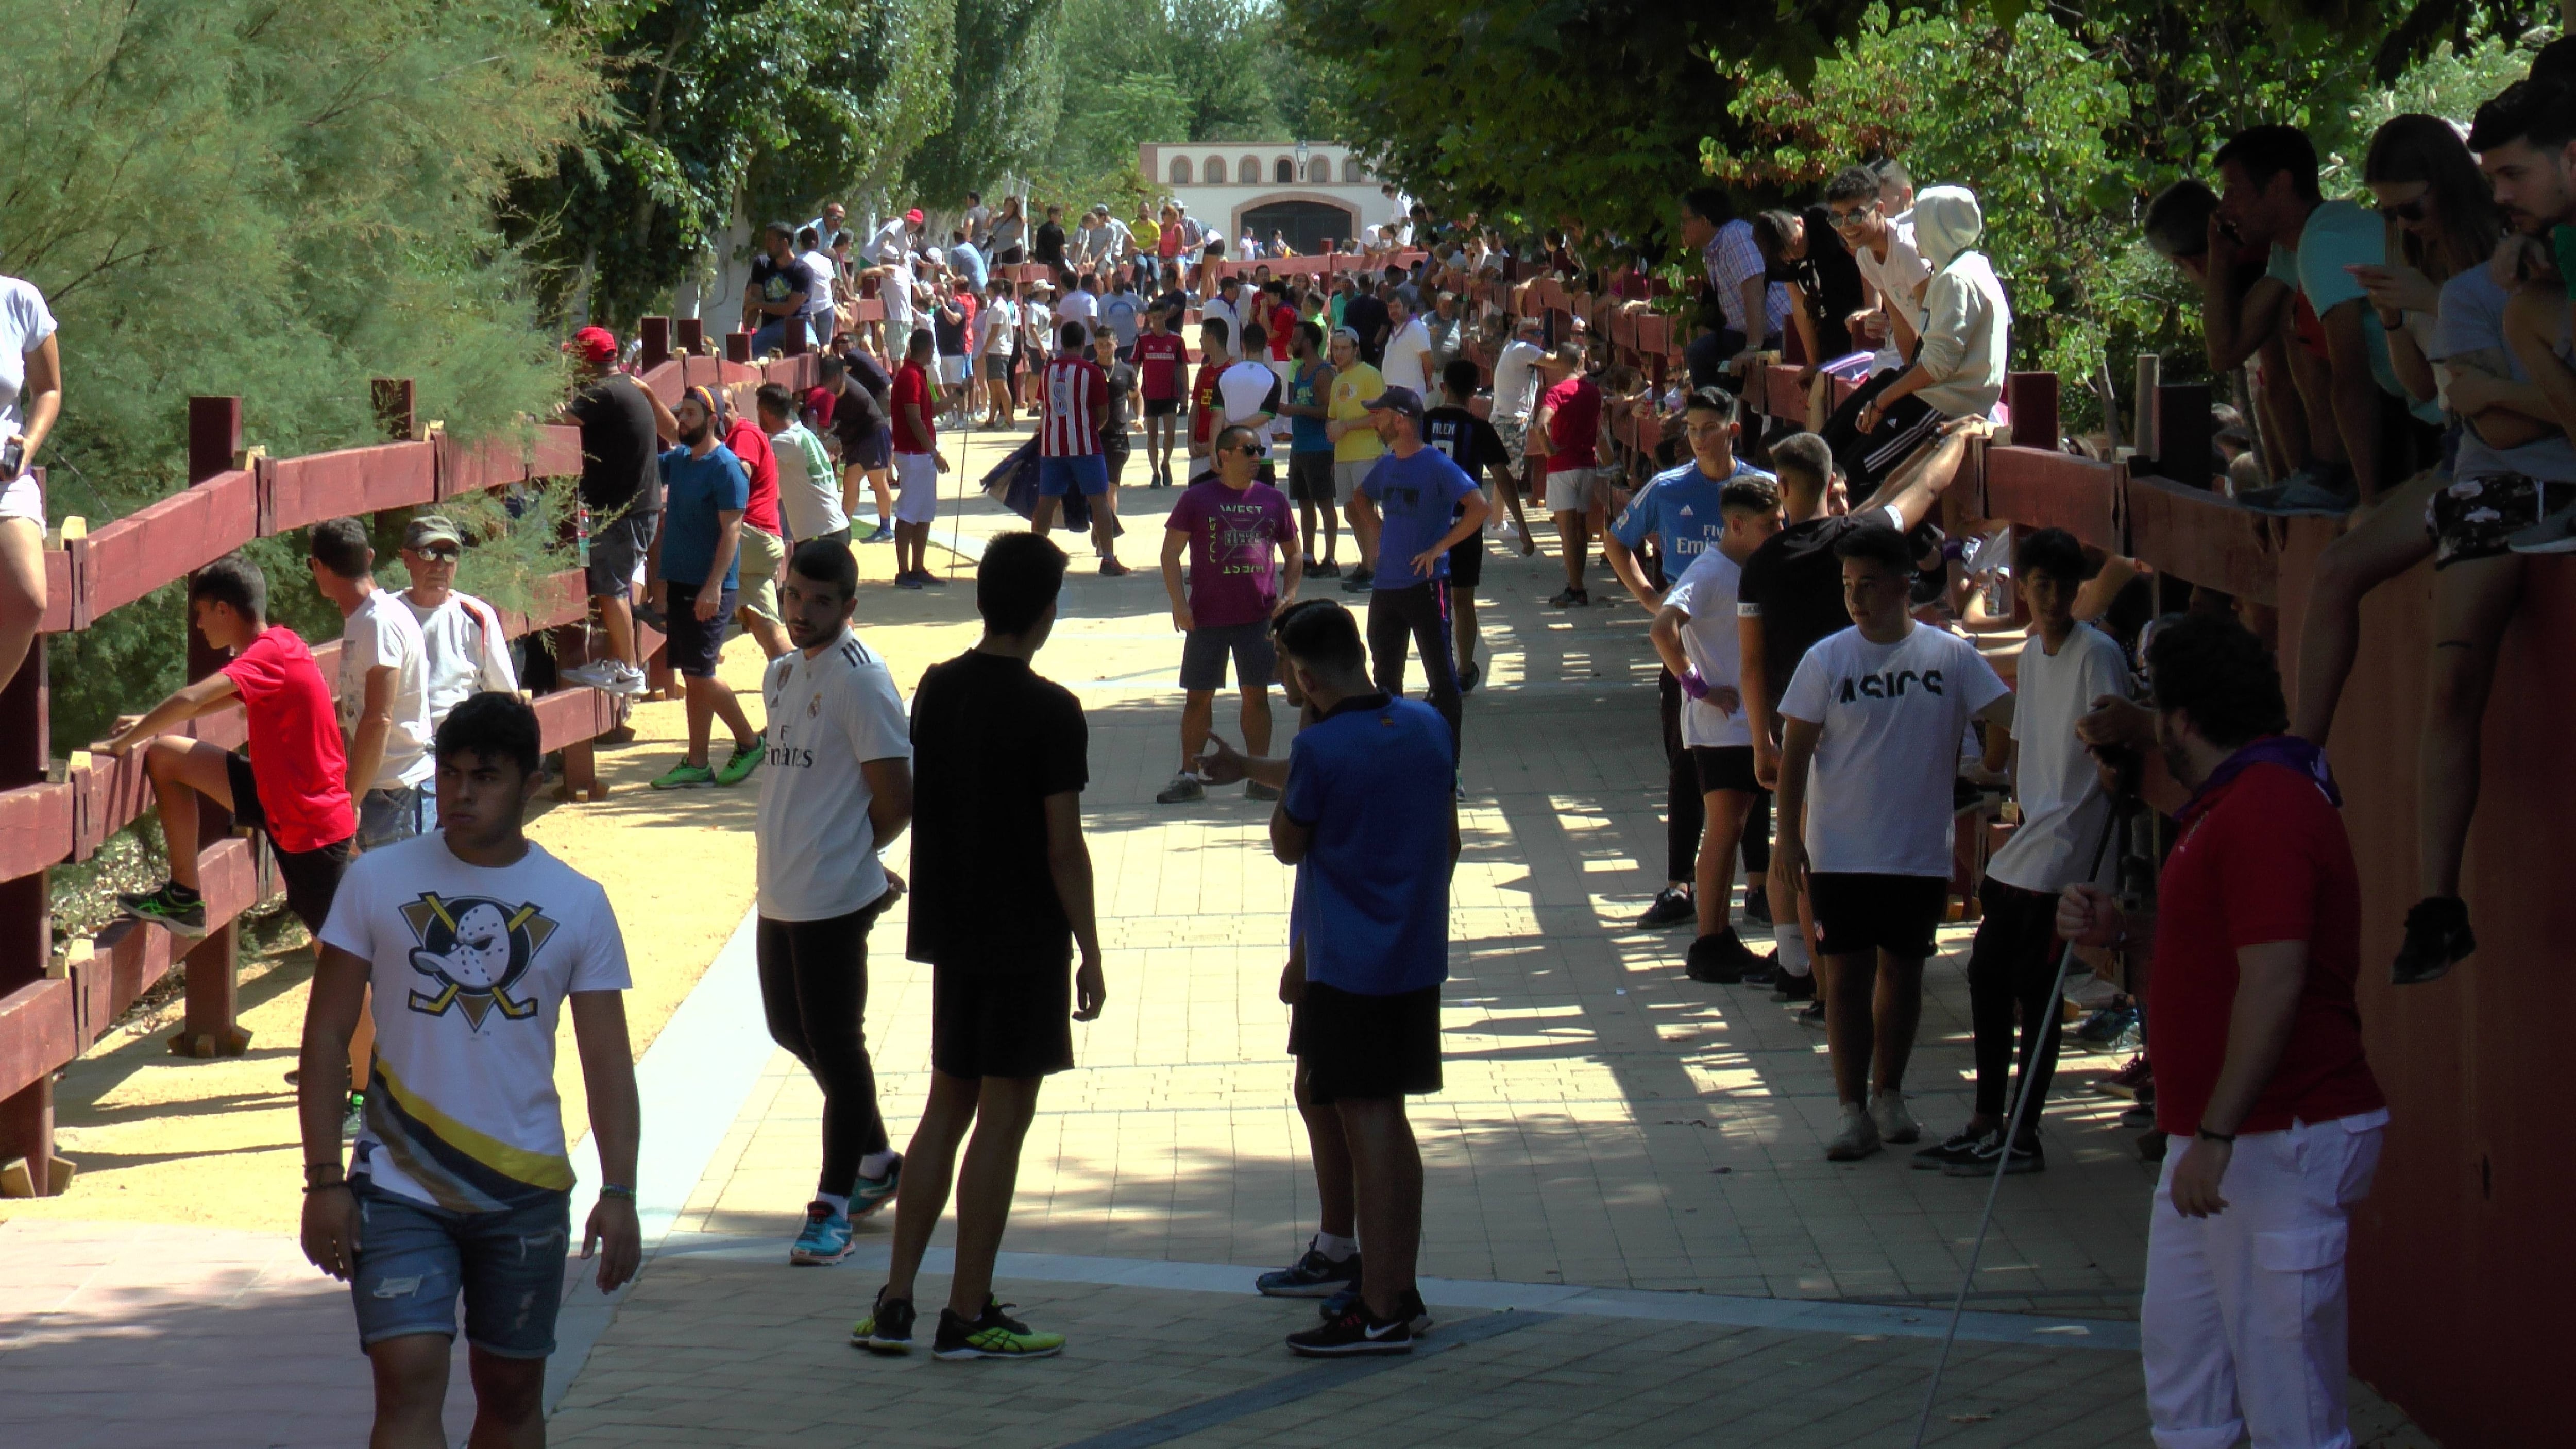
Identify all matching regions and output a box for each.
[1206,602,1458,1356]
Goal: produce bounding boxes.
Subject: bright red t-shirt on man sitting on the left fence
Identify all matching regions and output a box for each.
[222,623,358,855]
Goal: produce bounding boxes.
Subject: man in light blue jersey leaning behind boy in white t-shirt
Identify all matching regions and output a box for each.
[1602,388,1777,929]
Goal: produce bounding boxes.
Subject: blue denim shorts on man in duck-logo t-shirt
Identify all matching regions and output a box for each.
[348,1179,572,1359]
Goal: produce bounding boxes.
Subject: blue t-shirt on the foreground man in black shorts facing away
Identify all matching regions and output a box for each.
[1280,695,1458,996]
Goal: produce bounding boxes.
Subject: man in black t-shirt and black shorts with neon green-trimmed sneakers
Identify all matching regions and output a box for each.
[850,533,1105,1359]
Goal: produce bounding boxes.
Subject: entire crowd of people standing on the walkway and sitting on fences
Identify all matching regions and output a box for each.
[0,46,2576,1444]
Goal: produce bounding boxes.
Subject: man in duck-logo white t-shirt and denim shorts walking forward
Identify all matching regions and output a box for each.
[296,692,641,1449]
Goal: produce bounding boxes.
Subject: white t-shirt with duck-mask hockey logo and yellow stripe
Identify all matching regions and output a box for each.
[322,834,629,1212]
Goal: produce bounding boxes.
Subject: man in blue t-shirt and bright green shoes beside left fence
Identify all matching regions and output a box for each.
[644,386,762,790]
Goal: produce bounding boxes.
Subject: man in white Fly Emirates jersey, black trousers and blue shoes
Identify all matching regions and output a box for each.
[760,538,912,1264]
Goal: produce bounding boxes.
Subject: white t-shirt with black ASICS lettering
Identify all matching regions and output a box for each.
[1780,620,2007,878]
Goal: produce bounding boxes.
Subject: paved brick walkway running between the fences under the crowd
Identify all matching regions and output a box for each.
[0,419,2421,1446]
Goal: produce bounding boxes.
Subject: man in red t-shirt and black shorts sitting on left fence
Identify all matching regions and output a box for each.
[108,553,358,937]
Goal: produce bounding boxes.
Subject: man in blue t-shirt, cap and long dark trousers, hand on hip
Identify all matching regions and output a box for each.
[1350,386,1492,746]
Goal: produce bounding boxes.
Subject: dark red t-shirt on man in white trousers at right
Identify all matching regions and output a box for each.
[2146,764,2388,1140]
